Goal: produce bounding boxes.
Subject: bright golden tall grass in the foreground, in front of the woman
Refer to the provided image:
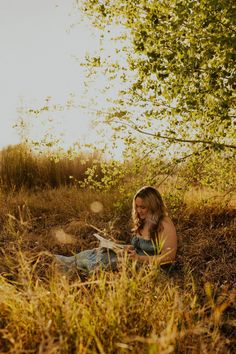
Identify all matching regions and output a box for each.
[0,254,235,353]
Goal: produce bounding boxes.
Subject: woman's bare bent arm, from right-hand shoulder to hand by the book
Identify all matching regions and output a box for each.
[129,217,177,264]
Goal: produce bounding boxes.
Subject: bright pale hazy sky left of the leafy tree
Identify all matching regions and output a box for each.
[0,0,121,155]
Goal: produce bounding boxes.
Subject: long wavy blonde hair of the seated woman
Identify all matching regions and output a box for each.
[132,186,168,241]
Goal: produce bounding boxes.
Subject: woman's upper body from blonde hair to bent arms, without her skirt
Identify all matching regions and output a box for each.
[128,186,177,265]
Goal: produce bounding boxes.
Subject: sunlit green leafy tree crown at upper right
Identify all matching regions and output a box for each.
[77,0,236,160]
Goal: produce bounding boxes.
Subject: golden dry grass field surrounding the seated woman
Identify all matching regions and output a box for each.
[0,187,236,354]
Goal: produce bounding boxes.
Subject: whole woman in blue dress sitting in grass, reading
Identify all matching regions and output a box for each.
[56,186,177,273]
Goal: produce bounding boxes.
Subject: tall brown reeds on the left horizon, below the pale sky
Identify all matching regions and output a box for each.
[0,144,102,190]
